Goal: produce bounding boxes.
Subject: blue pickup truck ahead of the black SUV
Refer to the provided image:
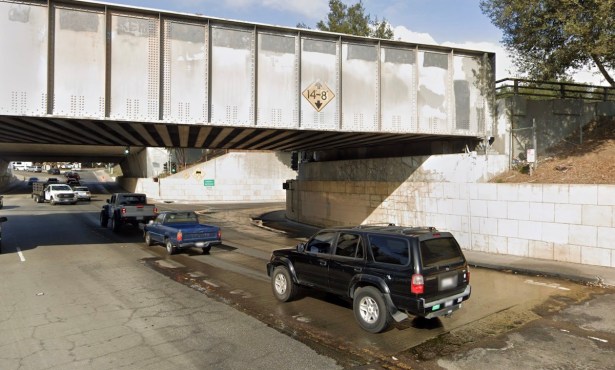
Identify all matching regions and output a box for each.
[143,211,222,254]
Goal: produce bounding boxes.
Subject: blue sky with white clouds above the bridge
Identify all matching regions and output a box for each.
[106,0,601,83]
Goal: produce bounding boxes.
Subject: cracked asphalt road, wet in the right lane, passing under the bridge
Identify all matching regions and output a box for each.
[0,172,615,369]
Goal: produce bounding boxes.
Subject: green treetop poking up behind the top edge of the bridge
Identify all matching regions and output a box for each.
[316,0,394,40]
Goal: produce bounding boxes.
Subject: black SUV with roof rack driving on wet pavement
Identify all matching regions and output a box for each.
[267,225,471,333]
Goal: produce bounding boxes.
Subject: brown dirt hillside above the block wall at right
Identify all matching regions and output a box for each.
[491,119,615,184]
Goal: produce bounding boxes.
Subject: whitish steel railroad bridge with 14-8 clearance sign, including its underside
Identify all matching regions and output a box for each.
[0,0,495,162]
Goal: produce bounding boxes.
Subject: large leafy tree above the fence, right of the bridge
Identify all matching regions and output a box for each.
[480,0,615,87]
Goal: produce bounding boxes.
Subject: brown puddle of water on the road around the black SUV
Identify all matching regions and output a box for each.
[142,244,603,368]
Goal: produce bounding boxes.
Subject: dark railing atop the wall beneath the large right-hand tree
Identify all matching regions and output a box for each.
[495,78,615,101]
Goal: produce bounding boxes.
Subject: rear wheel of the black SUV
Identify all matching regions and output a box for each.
[352,286,391,333]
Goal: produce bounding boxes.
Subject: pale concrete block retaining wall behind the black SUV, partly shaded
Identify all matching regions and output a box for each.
[287,155,615,267]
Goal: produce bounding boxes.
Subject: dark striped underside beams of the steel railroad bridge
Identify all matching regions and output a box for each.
[0,116,478,159]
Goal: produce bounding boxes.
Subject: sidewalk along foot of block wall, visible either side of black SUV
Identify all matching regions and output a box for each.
[258,211,615,286]
